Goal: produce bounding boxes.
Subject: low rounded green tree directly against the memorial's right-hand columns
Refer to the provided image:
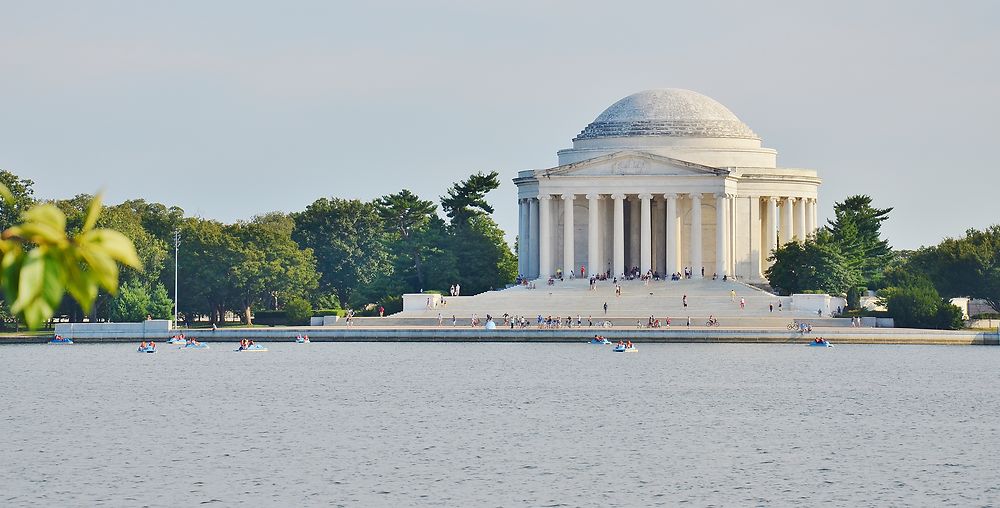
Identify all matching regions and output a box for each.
[765,230,860,295]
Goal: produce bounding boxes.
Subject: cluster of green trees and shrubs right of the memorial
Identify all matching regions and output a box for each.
[766,195,1000,329]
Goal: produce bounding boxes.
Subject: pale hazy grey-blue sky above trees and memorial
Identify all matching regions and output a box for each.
[0,0,1000,248]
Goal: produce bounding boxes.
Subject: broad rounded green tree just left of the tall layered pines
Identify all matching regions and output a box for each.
[292,198,391,304]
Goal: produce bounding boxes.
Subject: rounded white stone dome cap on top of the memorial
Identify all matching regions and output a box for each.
[574,88,760,141]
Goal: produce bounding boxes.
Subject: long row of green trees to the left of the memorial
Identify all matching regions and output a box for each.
[0,167,517,324]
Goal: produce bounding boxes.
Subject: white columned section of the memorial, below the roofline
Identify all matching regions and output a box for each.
[518,192,818,279]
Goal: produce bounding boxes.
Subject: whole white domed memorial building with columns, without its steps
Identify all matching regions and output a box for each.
[514,88,821,282]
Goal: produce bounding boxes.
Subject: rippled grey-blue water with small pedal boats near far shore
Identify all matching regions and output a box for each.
[0,343,1000,506]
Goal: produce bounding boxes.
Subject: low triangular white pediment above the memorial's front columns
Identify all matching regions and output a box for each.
[536,150,730,177]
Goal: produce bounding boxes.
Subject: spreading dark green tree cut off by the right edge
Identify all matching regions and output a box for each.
[909,224,1000,311]
